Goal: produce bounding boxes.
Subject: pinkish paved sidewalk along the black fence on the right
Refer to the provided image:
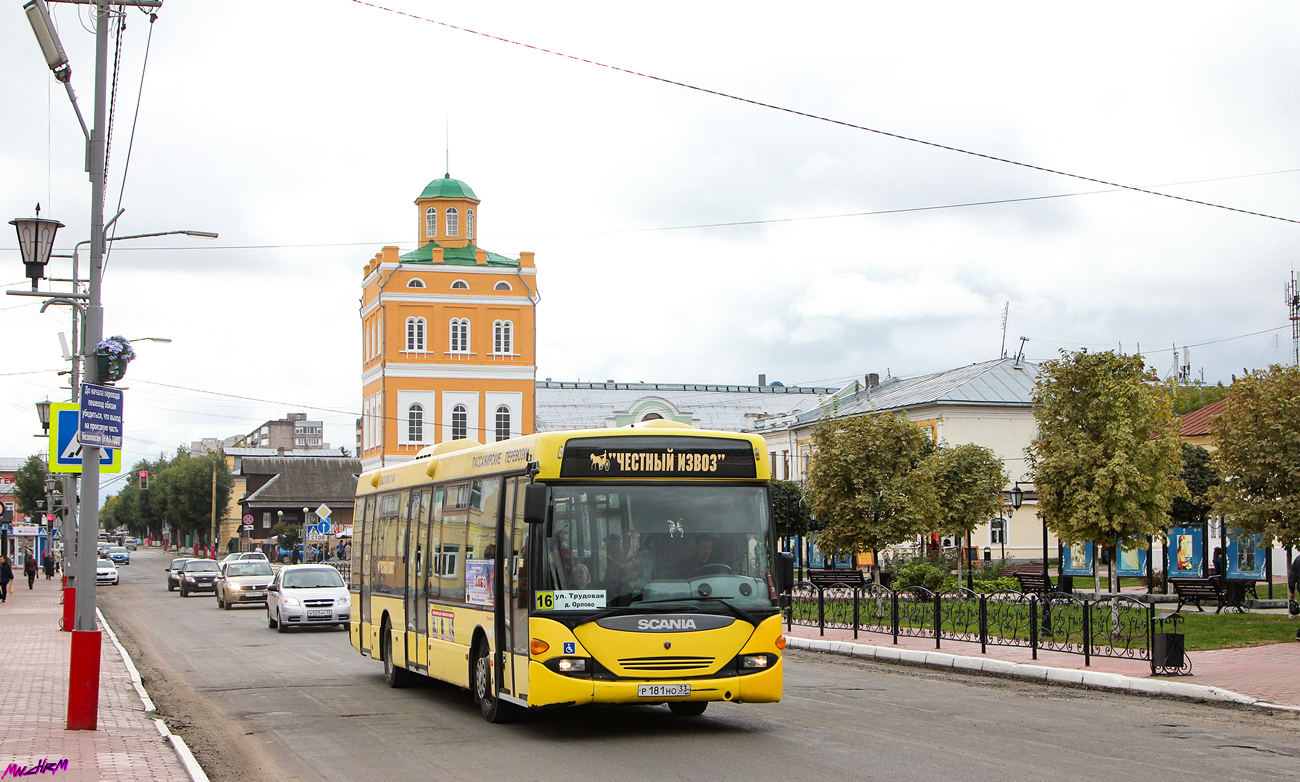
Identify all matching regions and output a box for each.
[787,615,1300,708]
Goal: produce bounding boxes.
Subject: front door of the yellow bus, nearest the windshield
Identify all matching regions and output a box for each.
[497,478,532,700]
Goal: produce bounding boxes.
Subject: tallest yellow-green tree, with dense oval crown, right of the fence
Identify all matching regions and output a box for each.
[1027,349,1186,590]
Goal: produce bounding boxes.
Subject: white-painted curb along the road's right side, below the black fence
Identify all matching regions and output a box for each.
[785,635,1300,714]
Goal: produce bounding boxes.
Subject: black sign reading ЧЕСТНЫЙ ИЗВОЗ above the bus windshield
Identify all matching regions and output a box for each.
[560,436,758,478]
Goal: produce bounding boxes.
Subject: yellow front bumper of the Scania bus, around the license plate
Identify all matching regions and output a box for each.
[528,659,783,707]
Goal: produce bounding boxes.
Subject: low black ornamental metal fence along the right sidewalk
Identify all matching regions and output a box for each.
[785,581,1156,665]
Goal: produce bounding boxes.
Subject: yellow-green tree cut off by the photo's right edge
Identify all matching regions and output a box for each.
[1210,365,1300,546]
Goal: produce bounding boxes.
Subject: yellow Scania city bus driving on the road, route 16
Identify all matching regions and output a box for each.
[350,421,793,722]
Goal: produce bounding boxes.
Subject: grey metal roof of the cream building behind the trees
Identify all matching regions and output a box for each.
[798,359,1039,423]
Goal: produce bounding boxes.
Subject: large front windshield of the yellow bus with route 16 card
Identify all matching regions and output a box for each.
[542,483,775,609]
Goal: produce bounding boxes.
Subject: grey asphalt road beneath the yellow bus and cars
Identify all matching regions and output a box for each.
[99,549,1300,782]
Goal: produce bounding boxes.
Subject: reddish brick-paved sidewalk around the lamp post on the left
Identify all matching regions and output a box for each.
[0,574,190,782]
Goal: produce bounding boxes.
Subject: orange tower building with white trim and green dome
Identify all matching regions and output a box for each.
[359,174,537,470]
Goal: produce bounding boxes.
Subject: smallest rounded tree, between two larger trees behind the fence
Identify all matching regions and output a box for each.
[922,443,1011,583]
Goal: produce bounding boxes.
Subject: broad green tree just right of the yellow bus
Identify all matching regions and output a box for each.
[807,414,935,569]
